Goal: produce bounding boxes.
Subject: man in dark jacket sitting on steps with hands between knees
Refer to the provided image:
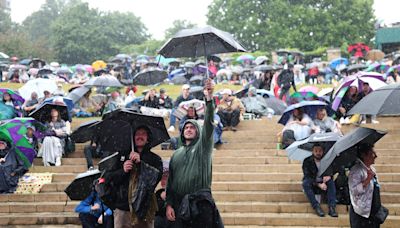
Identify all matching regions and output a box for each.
[302,144,338,217]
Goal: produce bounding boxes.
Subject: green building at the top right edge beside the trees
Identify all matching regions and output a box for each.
[375,23,400,53]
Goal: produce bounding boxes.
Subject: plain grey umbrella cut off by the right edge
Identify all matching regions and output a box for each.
[348,84,400,115]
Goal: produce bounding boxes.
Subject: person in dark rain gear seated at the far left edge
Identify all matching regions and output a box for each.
[0,139,28,194]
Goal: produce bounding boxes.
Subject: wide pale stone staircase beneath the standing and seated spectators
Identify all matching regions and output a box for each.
[0,117,400,227]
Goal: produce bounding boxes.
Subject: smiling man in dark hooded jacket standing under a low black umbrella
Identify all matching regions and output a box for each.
[106,126,163,227]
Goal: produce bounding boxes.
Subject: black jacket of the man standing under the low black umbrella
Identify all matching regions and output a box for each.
[105,149,163,211]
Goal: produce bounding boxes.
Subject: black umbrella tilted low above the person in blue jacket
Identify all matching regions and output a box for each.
[64,169,101,200]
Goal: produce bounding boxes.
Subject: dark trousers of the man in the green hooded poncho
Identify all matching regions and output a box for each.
[170,201,214,228]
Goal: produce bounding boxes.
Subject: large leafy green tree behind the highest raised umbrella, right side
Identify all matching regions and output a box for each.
[207,0,375,51]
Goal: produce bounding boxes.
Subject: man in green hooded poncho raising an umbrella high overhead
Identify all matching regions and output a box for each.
[166,79,222,227]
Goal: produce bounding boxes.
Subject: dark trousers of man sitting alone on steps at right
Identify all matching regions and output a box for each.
[303,178,336,208]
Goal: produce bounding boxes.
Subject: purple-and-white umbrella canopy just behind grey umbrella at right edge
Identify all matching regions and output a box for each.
[332,71,386,111]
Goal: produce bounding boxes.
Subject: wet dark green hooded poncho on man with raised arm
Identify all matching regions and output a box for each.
[166,101,214,209]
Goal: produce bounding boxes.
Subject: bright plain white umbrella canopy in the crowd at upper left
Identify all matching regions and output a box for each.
[18,78,57,100]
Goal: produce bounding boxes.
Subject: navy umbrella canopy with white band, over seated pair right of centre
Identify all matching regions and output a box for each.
[278,101,328,125]
